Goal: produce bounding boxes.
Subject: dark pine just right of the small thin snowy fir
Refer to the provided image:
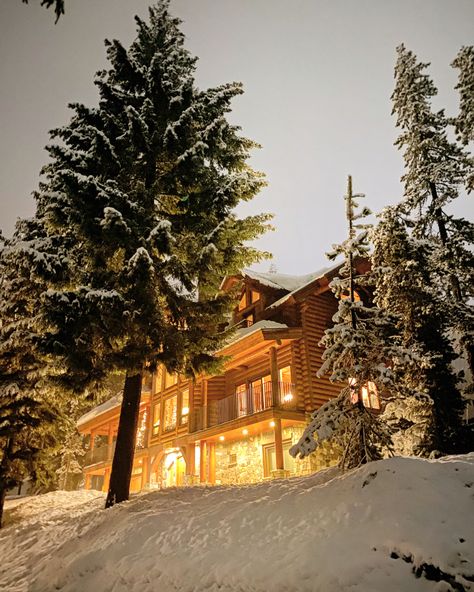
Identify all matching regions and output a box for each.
[372,206,463,455]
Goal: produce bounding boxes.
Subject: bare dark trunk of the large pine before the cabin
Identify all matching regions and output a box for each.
[105,373,142,508]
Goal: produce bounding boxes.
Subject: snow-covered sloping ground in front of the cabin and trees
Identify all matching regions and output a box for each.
[0,454,474,592]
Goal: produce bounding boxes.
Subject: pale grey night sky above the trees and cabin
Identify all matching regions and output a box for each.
[0,0,474,274]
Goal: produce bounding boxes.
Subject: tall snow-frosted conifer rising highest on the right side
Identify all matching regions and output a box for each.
[392,45,474,376]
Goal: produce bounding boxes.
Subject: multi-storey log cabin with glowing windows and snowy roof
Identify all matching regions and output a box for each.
[78,261,374,492]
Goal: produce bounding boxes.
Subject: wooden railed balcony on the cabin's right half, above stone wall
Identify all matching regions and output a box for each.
[189,382,296,432]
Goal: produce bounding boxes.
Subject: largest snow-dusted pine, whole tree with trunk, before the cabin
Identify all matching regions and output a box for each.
[37,0,268,506]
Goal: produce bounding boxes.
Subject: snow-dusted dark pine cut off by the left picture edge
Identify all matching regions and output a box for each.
[0,220,66,525]
